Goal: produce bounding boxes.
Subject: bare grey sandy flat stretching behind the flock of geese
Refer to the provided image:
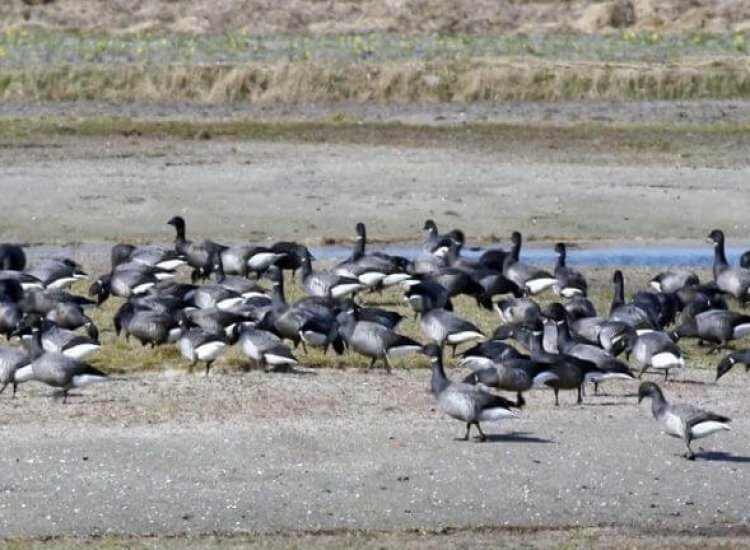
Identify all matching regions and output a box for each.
[0,123,750,245]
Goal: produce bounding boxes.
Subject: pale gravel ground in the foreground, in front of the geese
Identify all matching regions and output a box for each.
[0,369,750,537]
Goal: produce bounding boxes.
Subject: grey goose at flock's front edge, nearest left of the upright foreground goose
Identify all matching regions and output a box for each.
[338,309,422,373]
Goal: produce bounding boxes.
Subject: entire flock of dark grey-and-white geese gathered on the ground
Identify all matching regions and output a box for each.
[0,220,750,459]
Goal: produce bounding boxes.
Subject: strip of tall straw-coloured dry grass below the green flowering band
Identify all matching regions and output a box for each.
[0,57,750,103]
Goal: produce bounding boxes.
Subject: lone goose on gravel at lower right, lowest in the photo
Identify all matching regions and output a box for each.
[638,382,731,460]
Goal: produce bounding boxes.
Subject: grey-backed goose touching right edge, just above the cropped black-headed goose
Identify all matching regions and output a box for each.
[672,309,750,354]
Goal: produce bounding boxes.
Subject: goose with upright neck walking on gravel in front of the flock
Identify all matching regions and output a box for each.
[424,344,518,441]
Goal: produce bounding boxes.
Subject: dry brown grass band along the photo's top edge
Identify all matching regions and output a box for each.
[0,0,750,34]
